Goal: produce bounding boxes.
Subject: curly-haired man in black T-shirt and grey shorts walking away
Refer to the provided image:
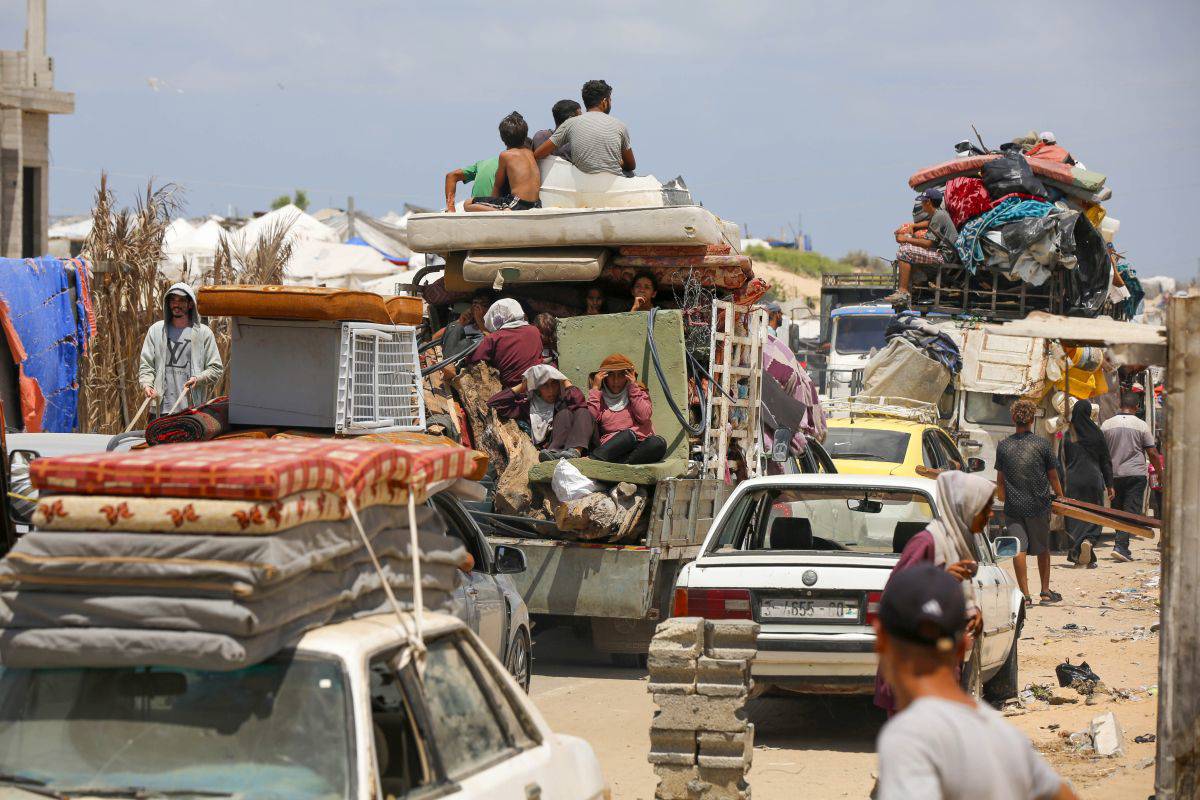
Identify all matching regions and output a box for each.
[996,398,1062,606]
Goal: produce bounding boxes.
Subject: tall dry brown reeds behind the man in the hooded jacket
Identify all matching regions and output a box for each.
[79,174,292,433]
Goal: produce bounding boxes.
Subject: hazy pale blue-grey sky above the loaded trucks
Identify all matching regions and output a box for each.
[9,0,1200,277]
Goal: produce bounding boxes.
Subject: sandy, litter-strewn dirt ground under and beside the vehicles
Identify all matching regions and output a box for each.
[532,532,1159,800]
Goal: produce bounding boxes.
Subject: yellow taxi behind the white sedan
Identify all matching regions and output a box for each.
[824,416,983,477]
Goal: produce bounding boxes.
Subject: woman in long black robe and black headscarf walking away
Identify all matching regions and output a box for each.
[1063,399,1112,567]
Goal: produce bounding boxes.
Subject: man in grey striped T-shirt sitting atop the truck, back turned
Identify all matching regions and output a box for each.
[533,80,637,176]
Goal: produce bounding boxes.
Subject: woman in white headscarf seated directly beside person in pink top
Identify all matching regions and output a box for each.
[487,363,595,461]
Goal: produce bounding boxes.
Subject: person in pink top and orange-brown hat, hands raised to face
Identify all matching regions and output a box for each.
[588,353,667,464]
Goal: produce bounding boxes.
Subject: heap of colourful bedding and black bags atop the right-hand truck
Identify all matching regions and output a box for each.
[908,136,1115,317]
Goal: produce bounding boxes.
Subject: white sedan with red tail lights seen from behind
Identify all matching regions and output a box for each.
[672,475,1025,702]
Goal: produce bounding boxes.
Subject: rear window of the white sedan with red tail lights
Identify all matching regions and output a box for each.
[708,486,934,553]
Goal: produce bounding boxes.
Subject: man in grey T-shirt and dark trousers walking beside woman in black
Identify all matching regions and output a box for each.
[1100,391,1163,561]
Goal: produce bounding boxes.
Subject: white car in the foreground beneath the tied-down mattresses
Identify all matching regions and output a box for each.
[0,613,608,800]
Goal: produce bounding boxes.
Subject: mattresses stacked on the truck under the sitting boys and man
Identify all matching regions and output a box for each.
[408,205,752,291]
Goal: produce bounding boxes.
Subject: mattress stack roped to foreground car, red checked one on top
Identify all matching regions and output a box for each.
[0,439,486,669]
